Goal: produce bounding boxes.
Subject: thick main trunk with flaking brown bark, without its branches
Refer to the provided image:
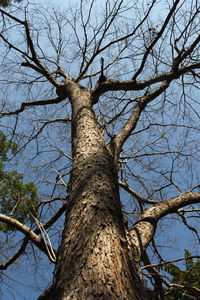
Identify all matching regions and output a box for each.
[52,84,148,300]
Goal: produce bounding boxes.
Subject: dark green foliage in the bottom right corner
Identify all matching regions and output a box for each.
[163,249,200,300]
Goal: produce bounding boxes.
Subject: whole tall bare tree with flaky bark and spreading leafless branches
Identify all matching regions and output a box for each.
[0,0,200,300]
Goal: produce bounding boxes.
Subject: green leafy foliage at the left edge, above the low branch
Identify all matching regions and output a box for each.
[0,131,38,231]
